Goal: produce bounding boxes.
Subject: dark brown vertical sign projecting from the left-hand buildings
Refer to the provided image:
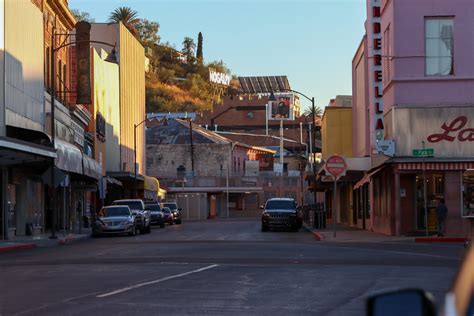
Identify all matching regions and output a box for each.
[76,21,92,104]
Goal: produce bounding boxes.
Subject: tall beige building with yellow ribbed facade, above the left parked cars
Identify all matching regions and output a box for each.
[91,23,146,195]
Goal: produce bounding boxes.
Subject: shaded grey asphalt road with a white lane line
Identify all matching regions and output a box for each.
[0,219,464,316]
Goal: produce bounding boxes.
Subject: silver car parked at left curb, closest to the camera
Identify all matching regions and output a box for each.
[92,205,138,236]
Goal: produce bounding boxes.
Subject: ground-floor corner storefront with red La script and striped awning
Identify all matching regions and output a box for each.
[370,106,474,237]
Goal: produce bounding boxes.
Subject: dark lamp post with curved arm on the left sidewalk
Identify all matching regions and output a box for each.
[49,26,117,239]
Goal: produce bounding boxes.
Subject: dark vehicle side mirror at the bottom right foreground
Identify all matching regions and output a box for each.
[367,289,436,316]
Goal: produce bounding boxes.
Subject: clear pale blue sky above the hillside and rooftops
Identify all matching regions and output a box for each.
[69,0,366,112]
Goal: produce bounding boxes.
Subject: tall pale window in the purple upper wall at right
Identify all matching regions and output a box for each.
[425,18,454,76]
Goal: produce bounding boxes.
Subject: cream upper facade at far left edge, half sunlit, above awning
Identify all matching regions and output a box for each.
[2,0,45,131]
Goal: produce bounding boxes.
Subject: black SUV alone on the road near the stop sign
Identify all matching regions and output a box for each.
[260,198,303,232]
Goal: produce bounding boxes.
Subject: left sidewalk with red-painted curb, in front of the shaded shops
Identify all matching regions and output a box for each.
[0,228,91,253]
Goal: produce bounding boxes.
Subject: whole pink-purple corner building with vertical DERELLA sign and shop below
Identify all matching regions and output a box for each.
[352,0,474,236]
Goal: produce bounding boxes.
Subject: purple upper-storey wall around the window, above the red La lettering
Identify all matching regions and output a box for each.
[382,0,474,109]
